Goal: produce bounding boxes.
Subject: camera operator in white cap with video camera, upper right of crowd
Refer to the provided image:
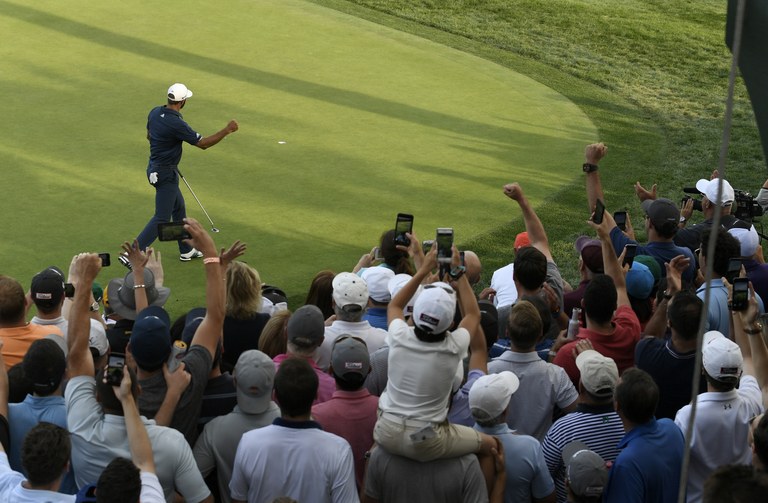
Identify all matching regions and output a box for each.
[674,176,757,251]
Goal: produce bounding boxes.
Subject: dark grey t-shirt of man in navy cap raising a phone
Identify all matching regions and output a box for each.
[139,345,213,445]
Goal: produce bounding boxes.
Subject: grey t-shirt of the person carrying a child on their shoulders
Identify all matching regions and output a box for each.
[365,447,488,503]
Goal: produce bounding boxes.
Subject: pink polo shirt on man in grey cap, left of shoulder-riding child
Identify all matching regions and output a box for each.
[312,388,379,487]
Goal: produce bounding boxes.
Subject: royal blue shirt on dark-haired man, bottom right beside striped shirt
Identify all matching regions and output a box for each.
[603,419,685,503]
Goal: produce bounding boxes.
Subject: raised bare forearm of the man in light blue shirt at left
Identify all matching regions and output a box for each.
[67,253,101,379]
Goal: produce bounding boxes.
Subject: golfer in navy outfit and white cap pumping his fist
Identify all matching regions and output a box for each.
[137,83,238,262]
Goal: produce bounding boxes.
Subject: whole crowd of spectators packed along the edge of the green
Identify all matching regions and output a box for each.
[0,143,768,503]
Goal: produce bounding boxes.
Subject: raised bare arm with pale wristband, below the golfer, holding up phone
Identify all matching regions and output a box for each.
[184,218,226,356]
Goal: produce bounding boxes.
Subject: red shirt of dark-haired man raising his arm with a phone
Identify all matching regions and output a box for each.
[552,306,640,388]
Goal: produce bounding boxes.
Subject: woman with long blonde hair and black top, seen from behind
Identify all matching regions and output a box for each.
[222,260,269,370]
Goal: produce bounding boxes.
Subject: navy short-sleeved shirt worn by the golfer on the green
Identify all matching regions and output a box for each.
[147,106,202,169]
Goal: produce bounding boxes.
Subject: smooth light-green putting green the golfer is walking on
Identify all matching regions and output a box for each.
[0,0,597,312]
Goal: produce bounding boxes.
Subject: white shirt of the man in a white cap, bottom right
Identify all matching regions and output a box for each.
[675,375,763,503]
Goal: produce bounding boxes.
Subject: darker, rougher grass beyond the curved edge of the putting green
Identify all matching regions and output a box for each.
[316,0,766,288]
